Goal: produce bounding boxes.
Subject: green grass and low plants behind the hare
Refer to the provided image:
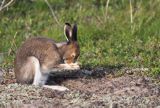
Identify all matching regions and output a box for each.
[0,0,160,75]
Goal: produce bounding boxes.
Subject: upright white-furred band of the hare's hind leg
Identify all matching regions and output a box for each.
[29,56,48,86]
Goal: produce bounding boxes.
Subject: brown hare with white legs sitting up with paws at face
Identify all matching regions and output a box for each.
[14,23,80,90]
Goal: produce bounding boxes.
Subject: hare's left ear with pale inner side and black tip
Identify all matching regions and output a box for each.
[64,23,72,41]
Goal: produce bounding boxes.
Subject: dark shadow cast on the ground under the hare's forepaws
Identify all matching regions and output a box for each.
[47,65,124,85]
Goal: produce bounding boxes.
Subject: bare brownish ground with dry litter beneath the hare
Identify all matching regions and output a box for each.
[0,67,160,108]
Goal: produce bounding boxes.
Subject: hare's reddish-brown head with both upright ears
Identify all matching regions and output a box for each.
[63,23,80,64]
